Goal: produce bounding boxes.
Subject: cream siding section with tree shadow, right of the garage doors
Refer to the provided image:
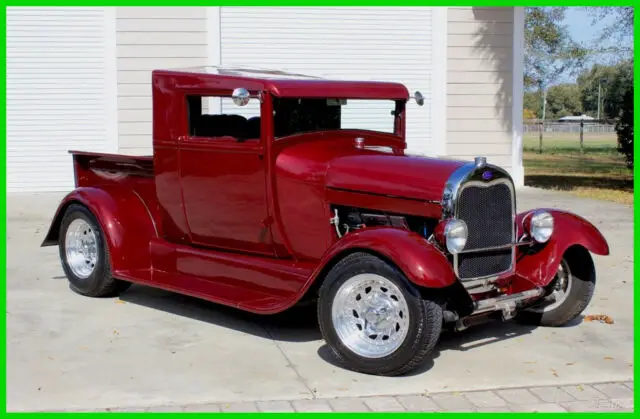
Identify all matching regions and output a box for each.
[446,7,521,174]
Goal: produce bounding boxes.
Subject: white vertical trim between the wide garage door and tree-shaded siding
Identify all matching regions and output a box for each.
[429,6,447,156]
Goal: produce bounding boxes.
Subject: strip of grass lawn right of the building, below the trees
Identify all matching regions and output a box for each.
[523,135,633,204]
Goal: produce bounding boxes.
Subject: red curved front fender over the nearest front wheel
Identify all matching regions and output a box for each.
[314,227,457,288]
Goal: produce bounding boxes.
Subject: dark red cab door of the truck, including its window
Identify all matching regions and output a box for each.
[179,95,273,254]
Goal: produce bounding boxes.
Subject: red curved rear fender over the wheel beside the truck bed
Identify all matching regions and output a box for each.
[42,185,158,275]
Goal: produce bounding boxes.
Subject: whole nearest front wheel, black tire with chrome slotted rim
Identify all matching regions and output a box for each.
[318,253,442,376]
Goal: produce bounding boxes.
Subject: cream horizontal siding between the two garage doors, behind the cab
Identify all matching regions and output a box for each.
[116,7,208,154]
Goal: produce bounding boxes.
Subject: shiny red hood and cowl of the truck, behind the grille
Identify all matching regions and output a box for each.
[275,130,466,202]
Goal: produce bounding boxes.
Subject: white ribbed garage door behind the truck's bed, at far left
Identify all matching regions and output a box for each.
[7,7,117,192]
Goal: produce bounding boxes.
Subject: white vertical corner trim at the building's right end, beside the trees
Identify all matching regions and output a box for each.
[511,7,524,187]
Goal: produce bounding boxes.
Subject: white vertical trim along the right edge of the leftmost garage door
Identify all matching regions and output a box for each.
[104,6,120,153]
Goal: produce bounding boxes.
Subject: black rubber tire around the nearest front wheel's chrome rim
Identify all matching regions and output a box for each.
[318,252,443,376]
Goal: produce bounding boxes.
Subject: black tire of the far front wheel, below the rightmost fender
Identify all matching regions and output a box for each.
[517,246,596,327]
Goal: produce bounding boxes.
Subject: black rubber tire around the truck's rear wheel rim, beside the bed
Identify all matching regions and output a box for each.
[58,204,131,297]
